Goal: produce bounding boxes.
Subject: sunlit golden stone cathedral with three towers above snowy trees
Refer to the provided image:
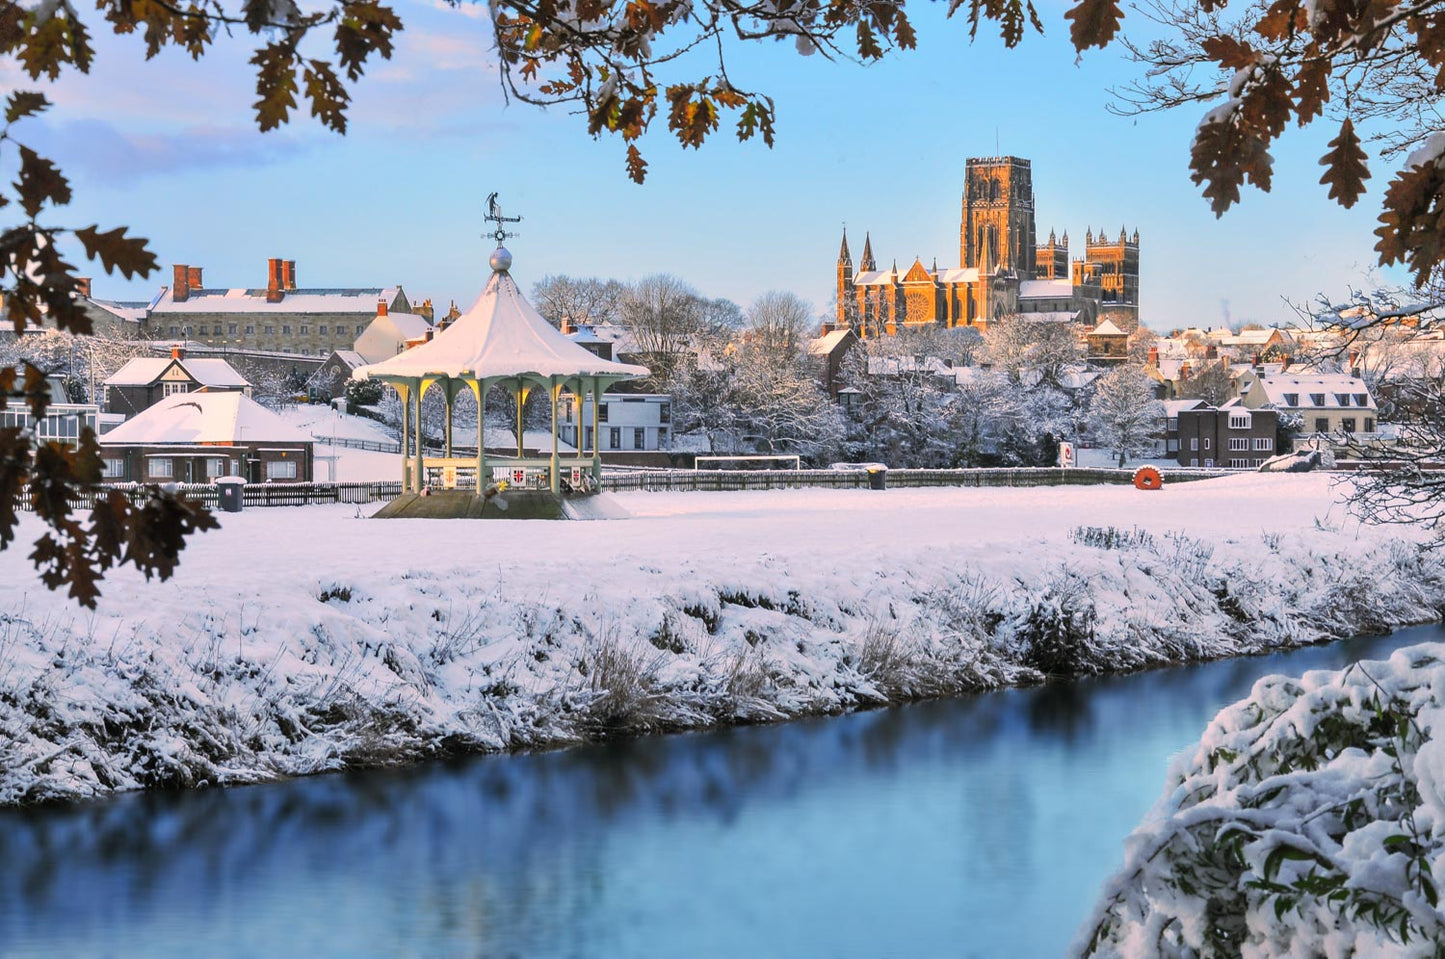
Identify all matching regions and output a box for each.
[835,156,1139,337]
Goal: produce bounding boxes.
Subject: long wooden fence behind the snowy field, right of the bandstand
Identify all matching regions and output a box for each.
[603,467,1230,492]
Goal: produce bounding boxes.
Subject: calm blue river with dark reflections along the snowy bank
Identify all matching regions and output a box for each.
[0,628,1421,958]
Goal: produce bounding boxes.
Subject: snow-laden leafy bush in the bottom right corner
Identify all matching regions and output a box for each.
[1075,644,1445,959]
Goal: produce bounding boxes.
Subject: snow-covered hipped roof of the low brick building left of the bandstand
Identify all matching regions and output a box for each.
[100,391,311,446]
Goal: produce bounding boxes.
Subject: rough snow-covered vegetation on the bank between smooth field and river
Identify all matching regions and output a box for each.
[0,514,1445,803]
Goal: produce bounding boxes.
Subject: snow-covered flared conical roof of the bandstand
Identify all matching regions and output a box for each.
[355,265,647,380]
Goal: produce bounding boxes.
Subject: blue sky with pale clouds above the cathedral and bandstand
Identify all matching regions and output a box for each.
[0,0,1387,329]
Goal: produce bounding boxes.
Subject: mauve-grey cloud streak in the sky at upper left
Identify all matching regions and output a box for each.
[23,120,315,185]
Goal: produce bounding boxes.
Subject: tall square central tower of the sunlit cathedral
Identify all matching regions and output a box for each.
[958,156,1036,280]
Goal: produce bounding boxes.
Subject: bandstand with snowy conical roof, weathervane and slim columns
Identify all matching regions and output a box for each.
[353,202,647,495]
